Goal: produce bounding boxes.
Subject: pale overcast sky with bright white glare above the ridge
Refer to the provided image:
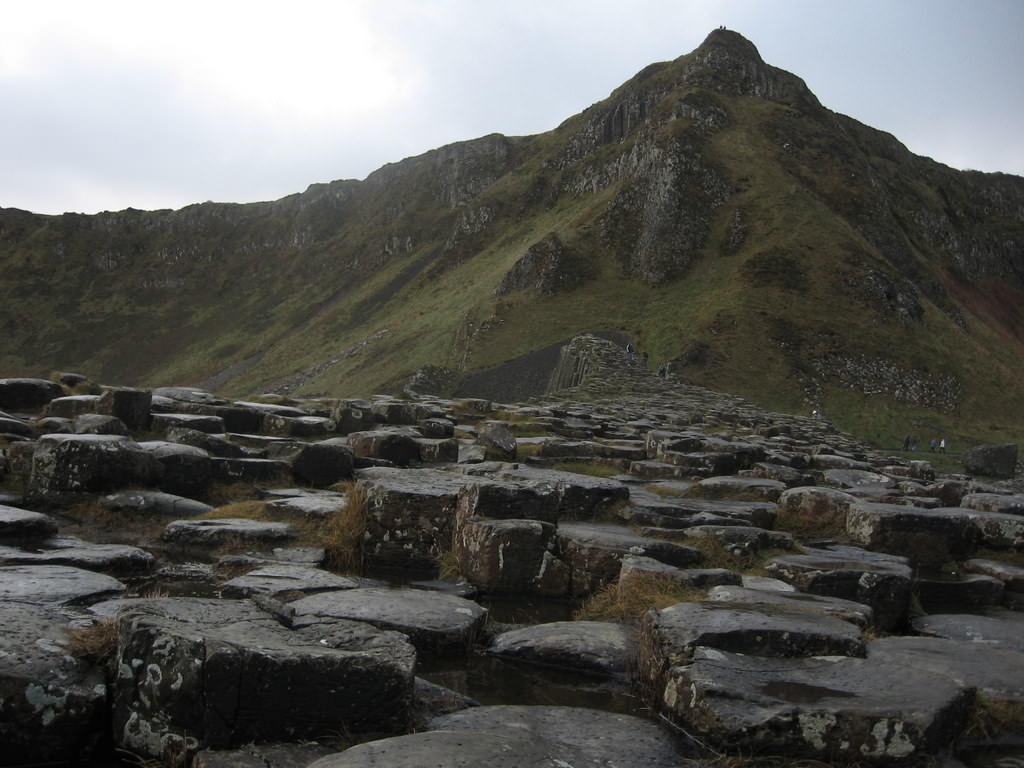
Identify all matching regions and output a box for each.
[0,0,1024,213]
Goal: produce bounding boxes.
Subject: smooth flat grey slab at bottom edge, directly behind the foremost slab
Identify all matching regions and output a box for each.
[419,706,693,768]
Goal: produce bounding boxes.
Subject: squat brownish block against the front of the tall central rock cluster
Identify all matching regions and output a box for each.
[453,517,569,597]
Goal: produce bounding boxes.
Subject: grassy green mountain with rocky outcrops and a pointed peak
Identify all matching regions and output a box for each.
[0,30,1024,441]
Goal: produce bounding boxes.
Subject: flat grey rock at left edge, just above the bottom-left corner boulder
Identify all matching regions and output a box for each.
[0,565,125,606]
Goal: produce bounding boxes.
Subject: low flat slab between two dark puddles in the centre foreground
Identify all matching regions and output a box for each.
[488,622,627,677]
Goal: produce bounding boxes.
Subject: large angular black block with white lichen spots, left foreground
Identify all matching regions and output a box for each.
[113,598,415,758]
